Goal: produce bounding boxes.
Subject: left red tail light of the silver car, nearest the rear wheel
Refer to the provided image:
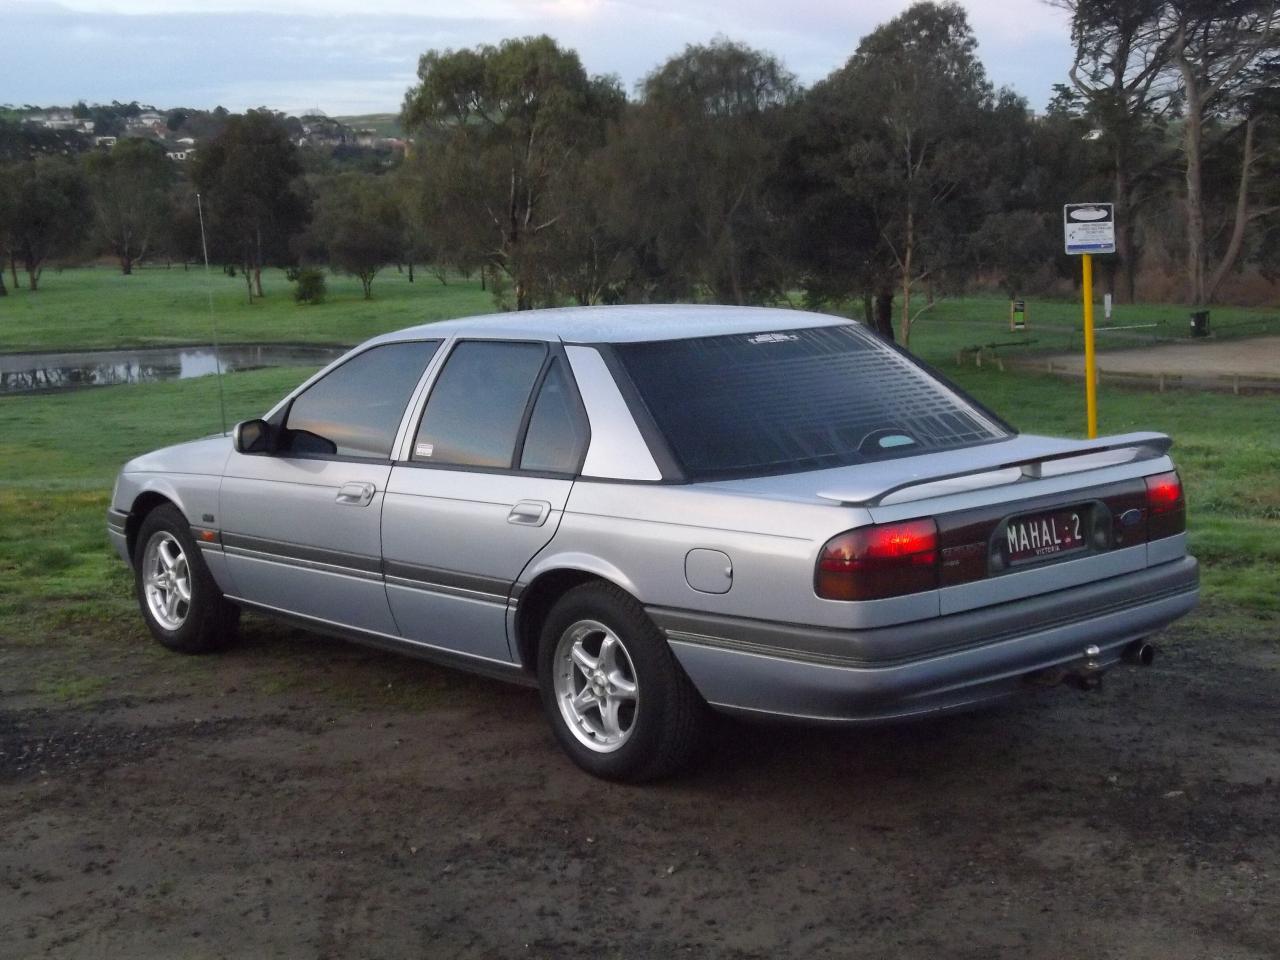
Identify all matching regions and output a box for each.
[814,520,938,600]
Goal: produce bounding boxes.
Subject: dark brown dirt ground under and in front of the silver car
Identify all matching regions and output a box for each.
[0,608,1280,960]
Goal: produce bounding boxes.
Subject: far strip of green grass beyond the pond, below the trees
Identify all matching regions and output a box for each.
[0,266,1280,362]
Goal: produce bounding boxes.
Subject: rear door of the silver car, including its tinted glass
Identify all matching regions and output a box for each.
[383,340,589,662]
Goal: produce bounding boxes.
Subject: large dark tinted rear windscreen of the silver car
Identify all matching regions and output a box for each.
[614,324,1009,480]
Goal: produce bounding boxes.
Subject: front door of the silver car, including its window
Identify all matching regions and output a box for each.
[219,340,440,636]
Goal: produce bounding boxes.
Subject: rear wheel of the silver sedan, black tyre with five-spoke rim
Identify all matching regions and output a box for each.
[538,584,708,782]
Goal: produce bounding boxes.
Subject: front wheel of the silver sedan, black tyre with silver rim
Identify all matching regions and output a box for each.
[133,503,239,653]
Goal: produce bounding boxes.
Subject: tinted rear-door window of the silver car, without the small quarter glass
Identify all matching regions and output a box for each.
[412,340,547,468]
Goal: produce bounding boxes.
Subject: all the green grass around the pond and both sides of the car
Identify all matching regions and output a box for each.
[0,270,1280,695]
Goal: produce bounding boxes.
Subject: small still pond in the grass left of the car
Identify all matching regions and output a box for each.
[0,343,347,394]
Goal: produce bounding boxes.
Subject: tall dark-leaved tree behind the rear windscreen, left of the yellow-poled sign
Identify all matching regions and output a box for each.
[819,3,1008,346]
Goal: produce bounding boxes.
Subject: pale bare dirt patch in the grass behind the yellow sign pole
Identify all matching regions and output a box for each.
[1028,337,1280,385]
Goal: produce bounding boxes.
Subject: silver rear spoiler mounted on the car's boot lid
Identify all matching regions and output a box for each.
[818,433,1174,507]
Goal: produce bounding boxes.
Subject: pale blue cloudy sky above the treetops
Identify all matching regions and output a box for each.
[0,0,1070,115]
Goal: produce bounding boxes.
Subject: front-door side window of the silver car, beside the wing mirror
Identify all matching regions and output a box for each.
[280,340,440,460]
